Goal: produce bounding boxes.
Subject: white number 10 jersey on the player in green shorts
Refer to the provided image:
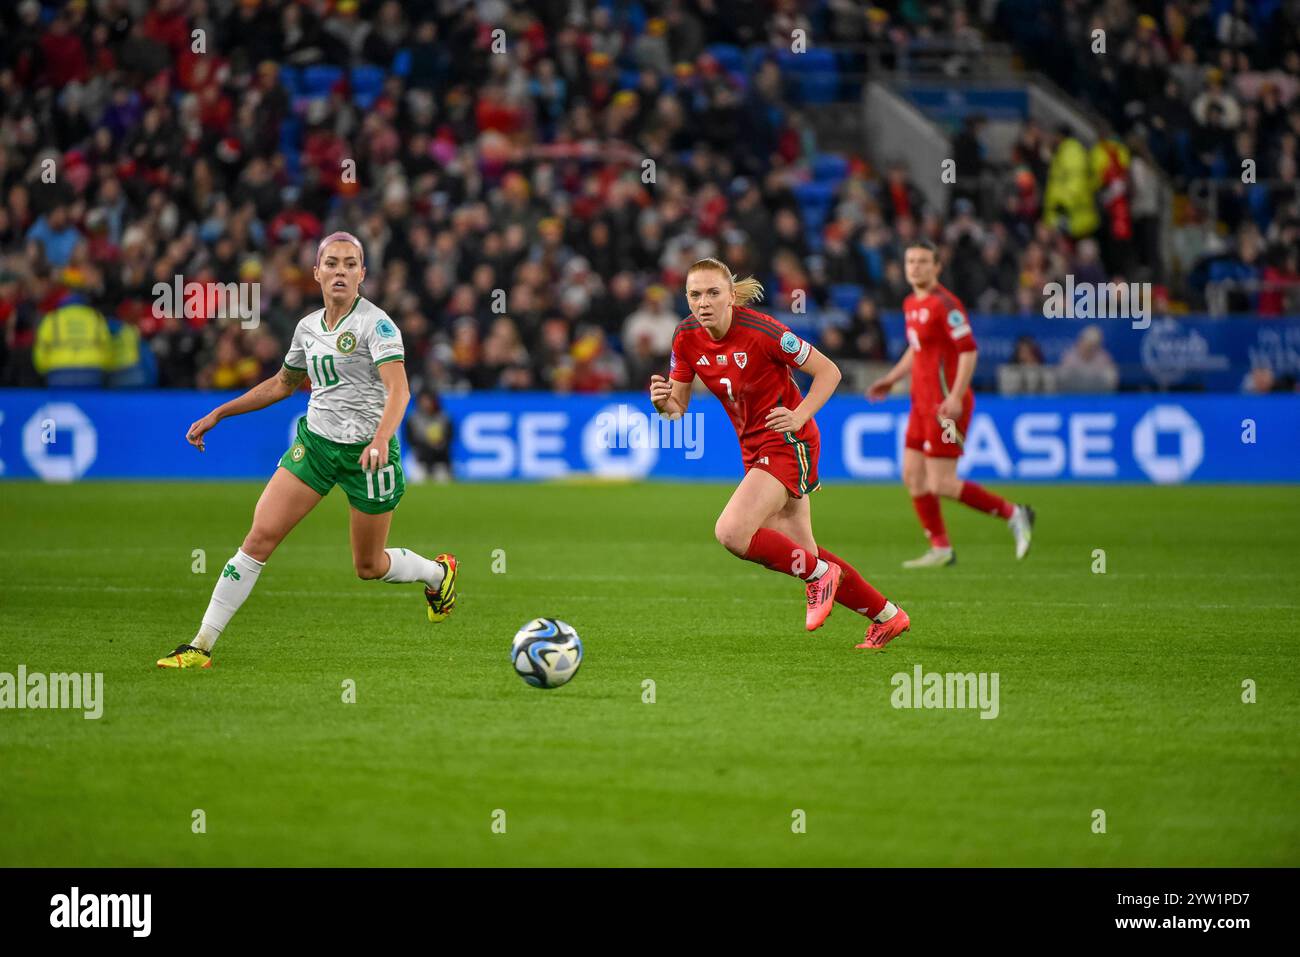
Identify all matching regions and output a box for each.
[285,295,406,445]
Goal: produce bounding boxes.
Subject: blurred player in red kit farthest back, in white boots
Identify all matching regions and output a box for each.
[867,241,1034,568]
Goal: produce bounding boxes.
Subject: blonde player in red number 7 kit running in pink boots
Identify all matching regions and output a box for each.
[650,259,911,649]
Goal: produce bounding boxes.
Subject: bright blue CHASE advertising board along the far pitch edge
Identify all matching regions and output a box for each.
[0,390,1300,484]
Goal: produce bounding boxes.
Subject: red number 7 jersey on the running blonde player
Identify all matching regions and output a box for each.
[668,306,819,452]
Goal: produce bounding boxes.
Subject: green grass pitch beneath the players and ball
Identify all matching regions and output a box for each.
[0,482,1300,866]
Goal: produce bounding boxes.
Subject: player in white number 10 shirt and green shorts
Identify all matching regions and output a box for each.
[157,233,456,668]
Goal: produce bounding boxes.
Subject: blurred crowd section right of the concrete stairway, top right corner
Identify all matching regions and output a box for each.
[997,0,1300,316]
